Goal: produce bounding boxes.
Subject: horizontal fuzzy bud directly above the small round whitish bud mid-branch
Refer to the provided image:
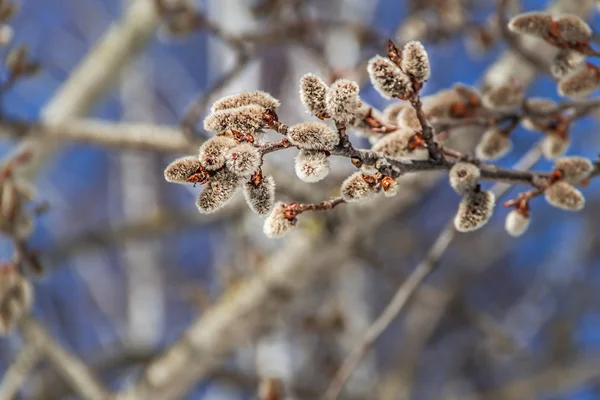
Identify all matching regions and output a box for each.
[288,121,340,151]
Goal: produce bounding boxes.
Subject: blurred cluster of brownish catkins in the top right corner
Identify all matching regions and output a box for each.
[509,12,600,98]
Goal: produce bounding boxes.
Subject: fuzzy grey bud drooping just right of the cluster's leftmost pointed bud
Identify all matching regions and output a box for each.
[196,168,239,214]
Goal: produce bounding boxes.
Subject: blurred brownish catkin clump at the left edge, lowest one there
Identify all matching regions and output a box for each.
[0,264,33,335]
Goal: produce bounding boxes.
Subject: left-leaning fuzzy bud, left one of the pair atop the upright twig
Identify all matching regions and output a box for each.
[367,56,414,99]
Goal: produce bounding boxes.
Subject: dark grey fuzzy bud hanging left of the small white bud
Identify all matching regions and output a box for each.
[454,191,496,232]
